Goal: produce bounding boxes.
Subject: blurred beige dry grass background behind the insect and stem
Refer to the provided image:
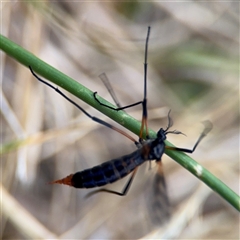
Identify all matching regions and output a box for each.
[1,1,239,239]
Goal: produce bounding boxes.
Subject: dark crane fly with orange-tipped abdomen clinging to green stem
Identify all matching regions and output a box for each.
[29,27,212,196]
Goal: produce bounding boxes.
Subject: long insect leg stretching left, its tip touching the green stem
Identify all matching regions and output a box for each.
[29,66,138,146]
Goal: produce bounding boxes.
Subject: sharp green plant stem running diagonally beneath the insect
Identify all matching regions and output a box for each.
[0,35,240,211]
